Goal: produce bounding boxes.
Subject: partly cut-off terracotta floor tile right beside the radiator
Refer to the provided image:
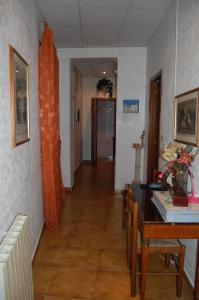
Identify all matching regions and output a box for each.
[33,266,57,294]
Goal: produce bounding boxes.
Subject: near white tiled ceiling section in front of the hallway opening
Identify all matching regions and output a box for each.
[38,0,171,48]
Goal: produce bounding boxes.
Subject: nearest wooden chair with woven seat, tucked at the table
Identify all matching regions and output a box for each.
[126,190,185,300]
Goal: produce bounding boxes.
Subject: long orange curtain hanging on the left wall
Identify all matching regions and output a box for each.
[39,24,64,230]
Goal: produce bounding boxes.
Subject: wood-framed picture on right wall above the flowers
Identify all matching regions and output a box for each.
[174,89,199,146]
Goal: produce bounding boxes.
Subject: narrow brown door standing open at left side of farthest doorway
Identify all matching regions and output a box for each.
[91,98,97,166]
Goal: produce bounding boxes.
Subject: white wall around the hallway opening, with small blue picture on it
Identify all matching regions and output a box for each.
[58,47,146,190]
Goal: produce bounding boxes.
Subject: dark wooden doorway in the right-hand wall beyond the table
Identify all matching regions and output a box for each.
[147,71,162,183]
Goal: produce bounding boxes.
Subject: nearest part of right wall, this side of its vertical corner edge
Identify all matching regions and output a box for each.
[175,0,199,281]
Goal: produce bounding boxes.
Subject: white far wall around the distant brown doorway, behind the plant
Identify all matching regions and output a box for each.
[82,77,116,160]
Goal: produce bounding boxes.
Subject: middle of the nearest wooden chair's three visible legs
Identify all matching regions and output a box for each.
[140,245,149,300]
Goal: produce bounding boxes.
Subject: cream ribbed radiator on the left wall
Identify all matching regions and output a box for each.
[0,215,34,300]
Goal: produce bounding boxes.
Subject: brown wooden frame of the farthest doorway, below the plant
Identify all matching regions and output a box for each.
[91,97,117,166]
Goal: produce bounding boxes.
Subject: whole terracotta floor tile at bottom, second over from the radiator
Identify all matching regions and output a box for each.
[48,269,96,298]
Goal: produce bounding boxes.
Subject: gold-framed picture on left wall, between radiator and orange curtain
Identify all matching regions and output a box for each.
[9,46,30,147]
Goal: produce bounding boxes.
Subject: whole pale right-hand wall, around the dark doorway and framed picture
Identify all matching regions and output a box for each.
[146,0,199,284]
